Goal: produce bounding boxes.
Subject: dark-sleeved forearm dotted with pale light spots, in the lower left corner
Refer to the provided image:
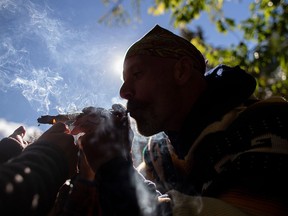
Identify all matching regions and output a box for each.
[0,143,68,215]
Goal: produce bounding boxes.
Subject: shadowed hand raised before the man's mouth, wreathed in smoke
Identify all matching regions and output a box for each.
[71,104,132,173]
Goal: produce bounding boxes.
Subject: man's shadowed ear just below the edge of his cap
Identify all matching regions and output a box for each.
[174,57,192,85]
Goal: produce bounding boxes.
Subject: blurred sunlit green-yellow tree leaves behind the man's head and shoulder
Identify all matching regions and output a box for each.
[99,0,288,98]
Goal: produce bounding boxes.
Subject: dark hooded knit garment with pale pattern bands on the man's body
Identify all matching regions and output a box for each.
[138,65,288,215]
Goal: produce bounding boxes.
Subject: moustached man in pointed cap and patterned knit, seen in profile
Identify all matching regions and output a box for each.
[76,25,288,216]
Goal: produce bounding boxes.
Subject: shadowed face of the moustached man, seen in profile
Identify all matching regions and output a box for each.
[120,56,178,136]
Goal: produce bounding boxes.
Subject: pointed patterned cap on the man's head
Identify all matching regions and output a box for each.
[125,25,206,74]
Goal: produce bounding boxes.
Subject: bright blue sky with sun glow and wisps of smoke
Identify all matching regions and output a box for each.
[0,0,251,138]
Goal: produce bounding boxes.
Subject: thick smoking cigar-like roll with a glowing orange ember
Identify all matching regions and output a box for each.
[37,113,80,125]
